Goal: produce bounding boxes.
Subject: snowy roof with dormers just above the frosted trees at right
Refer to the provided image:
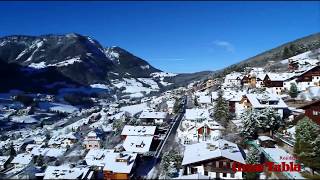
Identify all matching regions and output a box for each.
[246,93,288,108]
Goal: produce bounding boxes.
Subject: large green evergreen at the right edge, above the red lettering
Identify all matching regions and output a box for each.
[294,117,320,173]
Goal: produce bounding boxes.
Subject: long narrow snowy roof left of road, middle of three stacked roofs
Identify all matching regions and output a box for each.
[121,125,157,136]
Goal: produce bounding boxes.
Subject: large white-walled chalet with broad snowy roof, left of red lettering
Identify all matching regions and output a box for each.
[182,139,245,179]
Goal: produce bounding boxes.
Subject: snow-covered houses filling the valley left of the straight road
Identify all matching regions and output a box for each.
[0,90,181,179]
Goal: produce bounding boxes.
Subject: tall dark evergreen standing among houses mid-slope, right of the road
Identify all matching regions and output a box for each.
[213,90,230,126]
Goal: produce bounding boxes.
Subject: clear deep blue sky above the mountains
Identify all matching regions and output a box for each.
[0,1,320,73]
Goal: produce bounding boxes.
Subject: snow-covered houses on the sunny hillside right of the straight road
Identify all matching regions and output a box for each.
[176,53,320,179]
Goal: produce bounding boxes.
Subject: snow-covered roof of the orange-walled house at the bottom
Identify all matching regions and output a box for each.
[103,152,137,174]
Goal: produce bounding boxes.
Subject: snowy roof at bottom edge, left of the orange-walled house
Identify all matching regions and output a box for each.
[43,165,90,179]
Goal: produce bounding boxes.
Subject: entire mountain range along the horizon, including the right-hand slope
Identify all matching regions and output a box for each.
[0,33,320,92]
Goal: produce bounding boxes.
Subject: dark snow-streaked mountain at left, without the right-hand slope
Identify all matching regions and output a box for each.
[0,33,210,94]
